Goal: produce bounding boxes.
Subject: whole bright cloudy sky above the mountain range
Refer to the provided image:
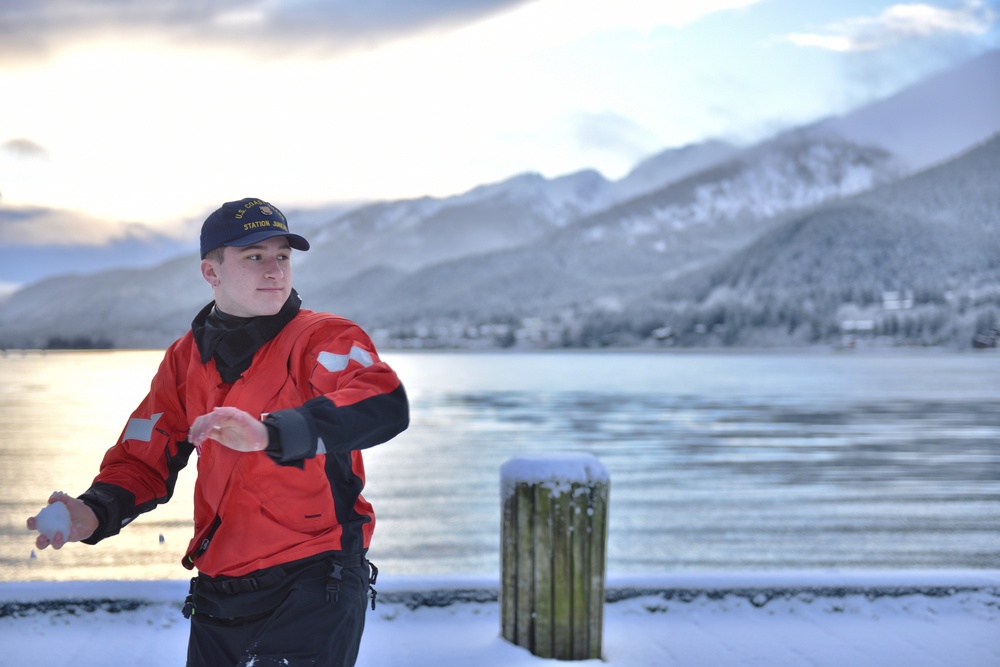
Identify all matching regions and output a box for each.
[0,0,1000,244]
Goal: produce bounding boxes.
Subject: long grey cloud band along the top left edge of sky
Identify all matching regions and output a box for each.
[0,0,529,61]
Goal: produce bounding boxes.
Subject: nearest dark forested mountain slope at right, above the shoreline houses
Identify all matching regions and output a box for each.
[665,134,1000,346]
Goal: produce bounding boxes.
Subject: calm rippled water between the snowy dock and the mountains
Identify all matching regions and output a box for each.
[0,351,1000,580]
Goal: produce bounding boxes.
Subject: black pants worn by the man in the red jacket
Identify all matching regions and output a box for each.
[187,555,369,667]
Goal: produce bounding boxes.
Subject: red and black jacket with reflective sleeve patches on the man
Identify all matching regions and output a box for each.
[81,310,409,576]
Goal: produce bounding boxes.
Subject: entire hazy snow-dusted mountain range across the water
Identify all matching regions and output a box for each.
[0,52,1000,346]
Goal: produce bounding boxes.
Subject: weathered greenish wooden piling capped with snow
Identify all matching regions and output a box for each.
[500,454,610,660]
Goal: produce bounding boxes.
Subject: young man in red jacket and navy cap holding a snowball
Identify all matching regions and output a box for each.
[28,198,409,667]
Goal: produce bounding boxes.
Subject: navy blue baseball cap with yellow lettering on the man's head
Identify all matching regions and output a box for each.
[201,197,309,259]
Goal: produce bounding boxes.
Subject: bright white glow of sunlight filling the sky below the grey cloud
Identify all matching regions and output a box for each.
[2,0,756,224]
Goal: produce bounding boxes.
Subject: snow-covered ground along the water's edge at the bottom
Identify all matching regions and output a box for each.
[0,571,1000,667]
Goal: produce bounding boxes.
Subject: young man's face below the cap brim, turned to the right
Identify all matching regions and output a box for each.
[201,236,292,317]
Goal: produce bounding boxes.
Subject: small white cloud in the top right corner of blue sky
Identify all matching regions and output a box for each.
[787,0,997,52]
